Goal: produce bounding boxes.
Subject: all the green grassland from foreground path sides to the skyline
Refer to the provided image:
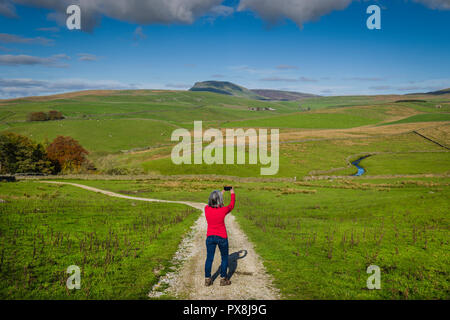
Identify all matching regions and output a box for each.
[0,90,450,299]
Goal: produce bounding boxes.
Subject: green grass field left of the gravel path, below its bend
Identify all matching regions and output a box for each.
[0,182,199,299]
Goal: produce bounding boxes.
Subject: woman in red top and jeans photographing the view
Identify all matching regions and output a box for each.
[205,188,235,286]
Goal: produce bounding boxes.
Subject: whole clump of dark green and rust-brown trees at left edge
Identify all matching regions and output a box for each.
[0,133,95,174]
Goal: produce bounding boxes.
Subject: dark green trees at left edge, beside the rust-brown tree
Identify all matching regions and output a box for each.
[0,132,55,174]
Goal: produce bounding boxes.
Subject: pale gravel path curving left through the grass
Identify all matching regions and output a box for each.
[40,181,281,300]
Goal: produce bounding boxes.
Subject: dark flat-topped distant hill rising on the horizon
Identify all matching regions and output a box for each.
[189,81,316,101]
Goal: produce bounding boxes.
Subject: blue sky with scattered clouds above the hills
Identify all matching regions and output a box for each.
[0,0,450,98]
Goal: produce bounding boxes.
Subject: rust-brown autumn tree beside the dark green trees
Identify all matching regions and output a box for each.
[47,136,89,173]
